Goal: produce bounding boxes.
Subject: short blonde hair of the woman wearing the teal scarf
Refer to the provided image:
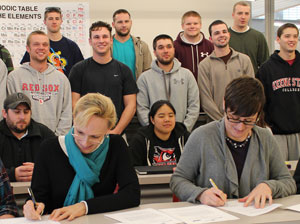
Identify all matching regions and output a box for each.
[73,93,117,129]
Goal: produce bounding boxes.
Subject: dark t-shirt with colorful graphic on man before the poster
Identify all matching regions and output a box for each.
[20,36,84,76]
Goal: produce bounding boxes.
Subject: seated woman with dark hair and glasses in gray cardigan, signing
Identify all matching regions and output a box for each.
[170,76,296,208]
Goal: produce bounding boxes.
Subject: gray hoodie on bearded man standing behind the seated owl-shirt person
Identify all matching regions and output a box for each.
[137,58,200,131]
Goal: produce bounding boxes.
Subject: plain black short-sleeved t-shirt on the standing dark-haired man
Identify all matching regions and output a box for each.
[69,58,138,118]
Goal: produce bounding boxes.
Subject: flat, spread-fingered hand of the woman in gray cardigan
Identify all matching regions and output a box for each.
[239,183,272,208]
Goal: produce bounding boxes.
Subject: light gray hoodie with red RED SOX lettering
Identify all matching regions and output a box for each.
[7,63,72,135]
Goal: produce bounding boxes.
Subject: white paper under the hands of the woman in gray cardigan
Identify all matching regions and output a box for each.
[220,200,281,216]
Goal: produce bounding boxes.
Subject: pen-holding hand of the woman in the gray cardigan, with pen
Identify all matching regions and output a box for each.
[198,178,227,207]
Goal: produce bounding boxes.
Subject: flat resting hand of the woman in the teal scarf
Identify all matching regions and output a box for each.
[50,202,86,221]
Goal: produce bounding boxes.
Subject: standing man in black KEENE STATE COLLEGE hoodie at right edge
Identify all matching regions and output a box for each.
[256,23,300,160]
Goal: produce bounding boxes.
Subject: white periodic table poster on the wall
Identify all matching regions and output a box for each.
[0,2,90,67]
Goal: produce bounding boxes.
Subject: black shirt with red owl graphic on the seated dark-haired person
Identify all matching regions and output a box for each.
[149,132,181,166]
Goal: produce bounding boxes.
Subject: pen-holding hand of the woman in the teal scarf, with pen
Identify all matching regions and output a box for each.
[23,187,45,220]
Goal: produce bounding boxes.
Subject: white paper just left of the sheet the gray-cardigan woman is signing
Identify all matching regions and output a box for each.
[160,205,239,224]
